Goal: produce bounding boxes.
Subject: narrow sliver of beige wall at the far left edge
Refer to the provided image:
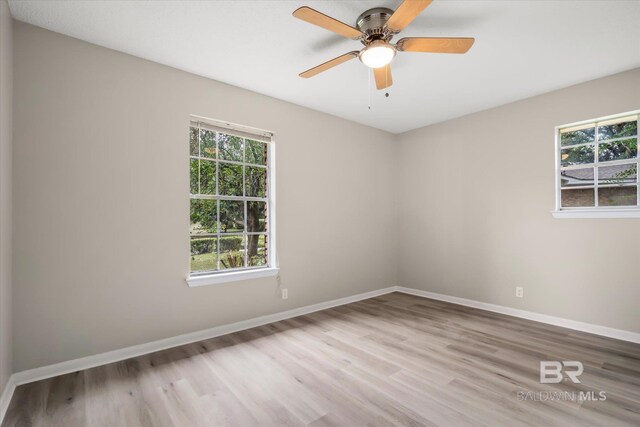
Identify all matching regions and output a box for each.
[0,0,13,393]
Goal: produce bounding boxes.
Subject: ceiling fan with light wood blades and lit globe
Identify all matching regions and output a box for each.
[293,0,475,89]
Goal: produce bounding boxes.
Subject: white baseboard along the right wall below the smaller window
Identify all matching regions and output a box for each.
[396,286,640,344]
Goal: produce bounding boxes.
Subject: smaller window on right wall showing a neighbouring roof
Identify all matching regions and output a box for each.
[556,113,640,216]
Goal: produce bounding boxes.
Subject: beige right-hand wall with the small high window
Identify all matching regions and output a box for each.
[398,69,640,332]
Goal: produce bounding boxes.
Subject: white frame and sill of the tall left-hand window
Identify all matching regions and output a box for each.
[186,116,280,287]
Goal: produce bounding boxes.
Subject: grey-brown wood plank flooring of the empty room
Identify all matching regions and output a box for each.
[2,293,640,427]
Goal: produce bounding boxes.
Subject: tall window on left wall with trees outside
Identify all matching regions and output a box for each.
[189,120,275,286]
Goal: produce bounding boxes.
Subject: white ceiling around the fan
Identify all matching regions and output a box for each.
[9,0,640,133]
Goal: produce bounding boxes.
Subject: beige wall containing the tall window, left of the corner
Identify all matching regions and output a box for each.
[14,22,396,371]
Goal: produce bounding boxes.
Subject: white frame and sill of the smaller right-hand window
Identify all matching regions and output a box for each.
[551,110,640,218]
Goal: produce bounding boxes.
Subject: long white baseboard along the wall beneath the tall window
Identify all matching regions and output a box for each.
[11,286,396,388]
